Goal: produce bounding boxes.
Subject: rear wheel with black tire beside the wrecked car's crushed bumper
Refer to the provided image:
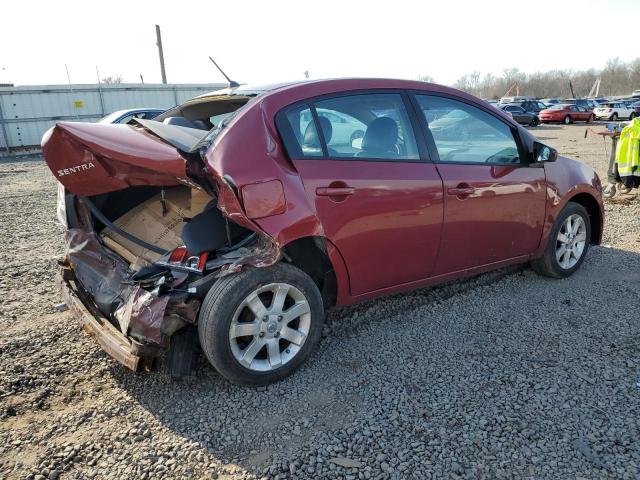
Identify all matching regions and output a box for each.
[198,262,324,385]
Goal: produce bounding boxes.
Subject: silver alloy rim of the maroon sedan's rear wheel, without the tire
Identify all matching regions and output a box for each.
[229,283,311,372]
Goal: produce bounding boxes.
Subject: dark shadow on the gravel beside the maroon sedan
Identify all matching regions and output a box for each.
[111,247,640,478]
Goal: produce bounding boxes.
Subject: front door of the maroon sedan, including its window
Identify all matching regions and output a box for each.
[415,94,546,275]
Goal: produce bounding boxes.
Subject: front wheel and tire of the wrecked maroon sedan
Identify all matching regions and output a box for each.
[531,202,591,278]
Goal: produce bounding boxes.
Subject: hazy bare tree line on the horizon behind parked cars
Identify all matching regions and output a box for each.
[419,57,640,99]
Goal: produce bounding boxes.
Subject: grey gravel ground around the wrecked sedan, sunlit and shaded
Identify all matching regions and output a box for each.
[0,125,640,479]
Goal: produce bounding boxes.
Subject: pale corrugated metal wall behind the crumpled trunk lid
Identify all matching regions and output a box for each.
[0,83,226,158]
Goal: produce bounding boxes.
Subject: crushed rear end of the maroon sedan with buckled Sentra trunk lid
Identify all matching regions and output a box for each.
[42,96,281,373]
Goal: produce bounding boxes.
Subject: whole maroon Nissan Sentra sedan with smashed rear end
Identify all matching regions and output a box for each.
[43,79,603,385]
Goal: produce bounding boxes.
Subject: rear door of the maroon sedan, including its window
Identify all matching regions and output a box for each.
[276,91,443,295]
